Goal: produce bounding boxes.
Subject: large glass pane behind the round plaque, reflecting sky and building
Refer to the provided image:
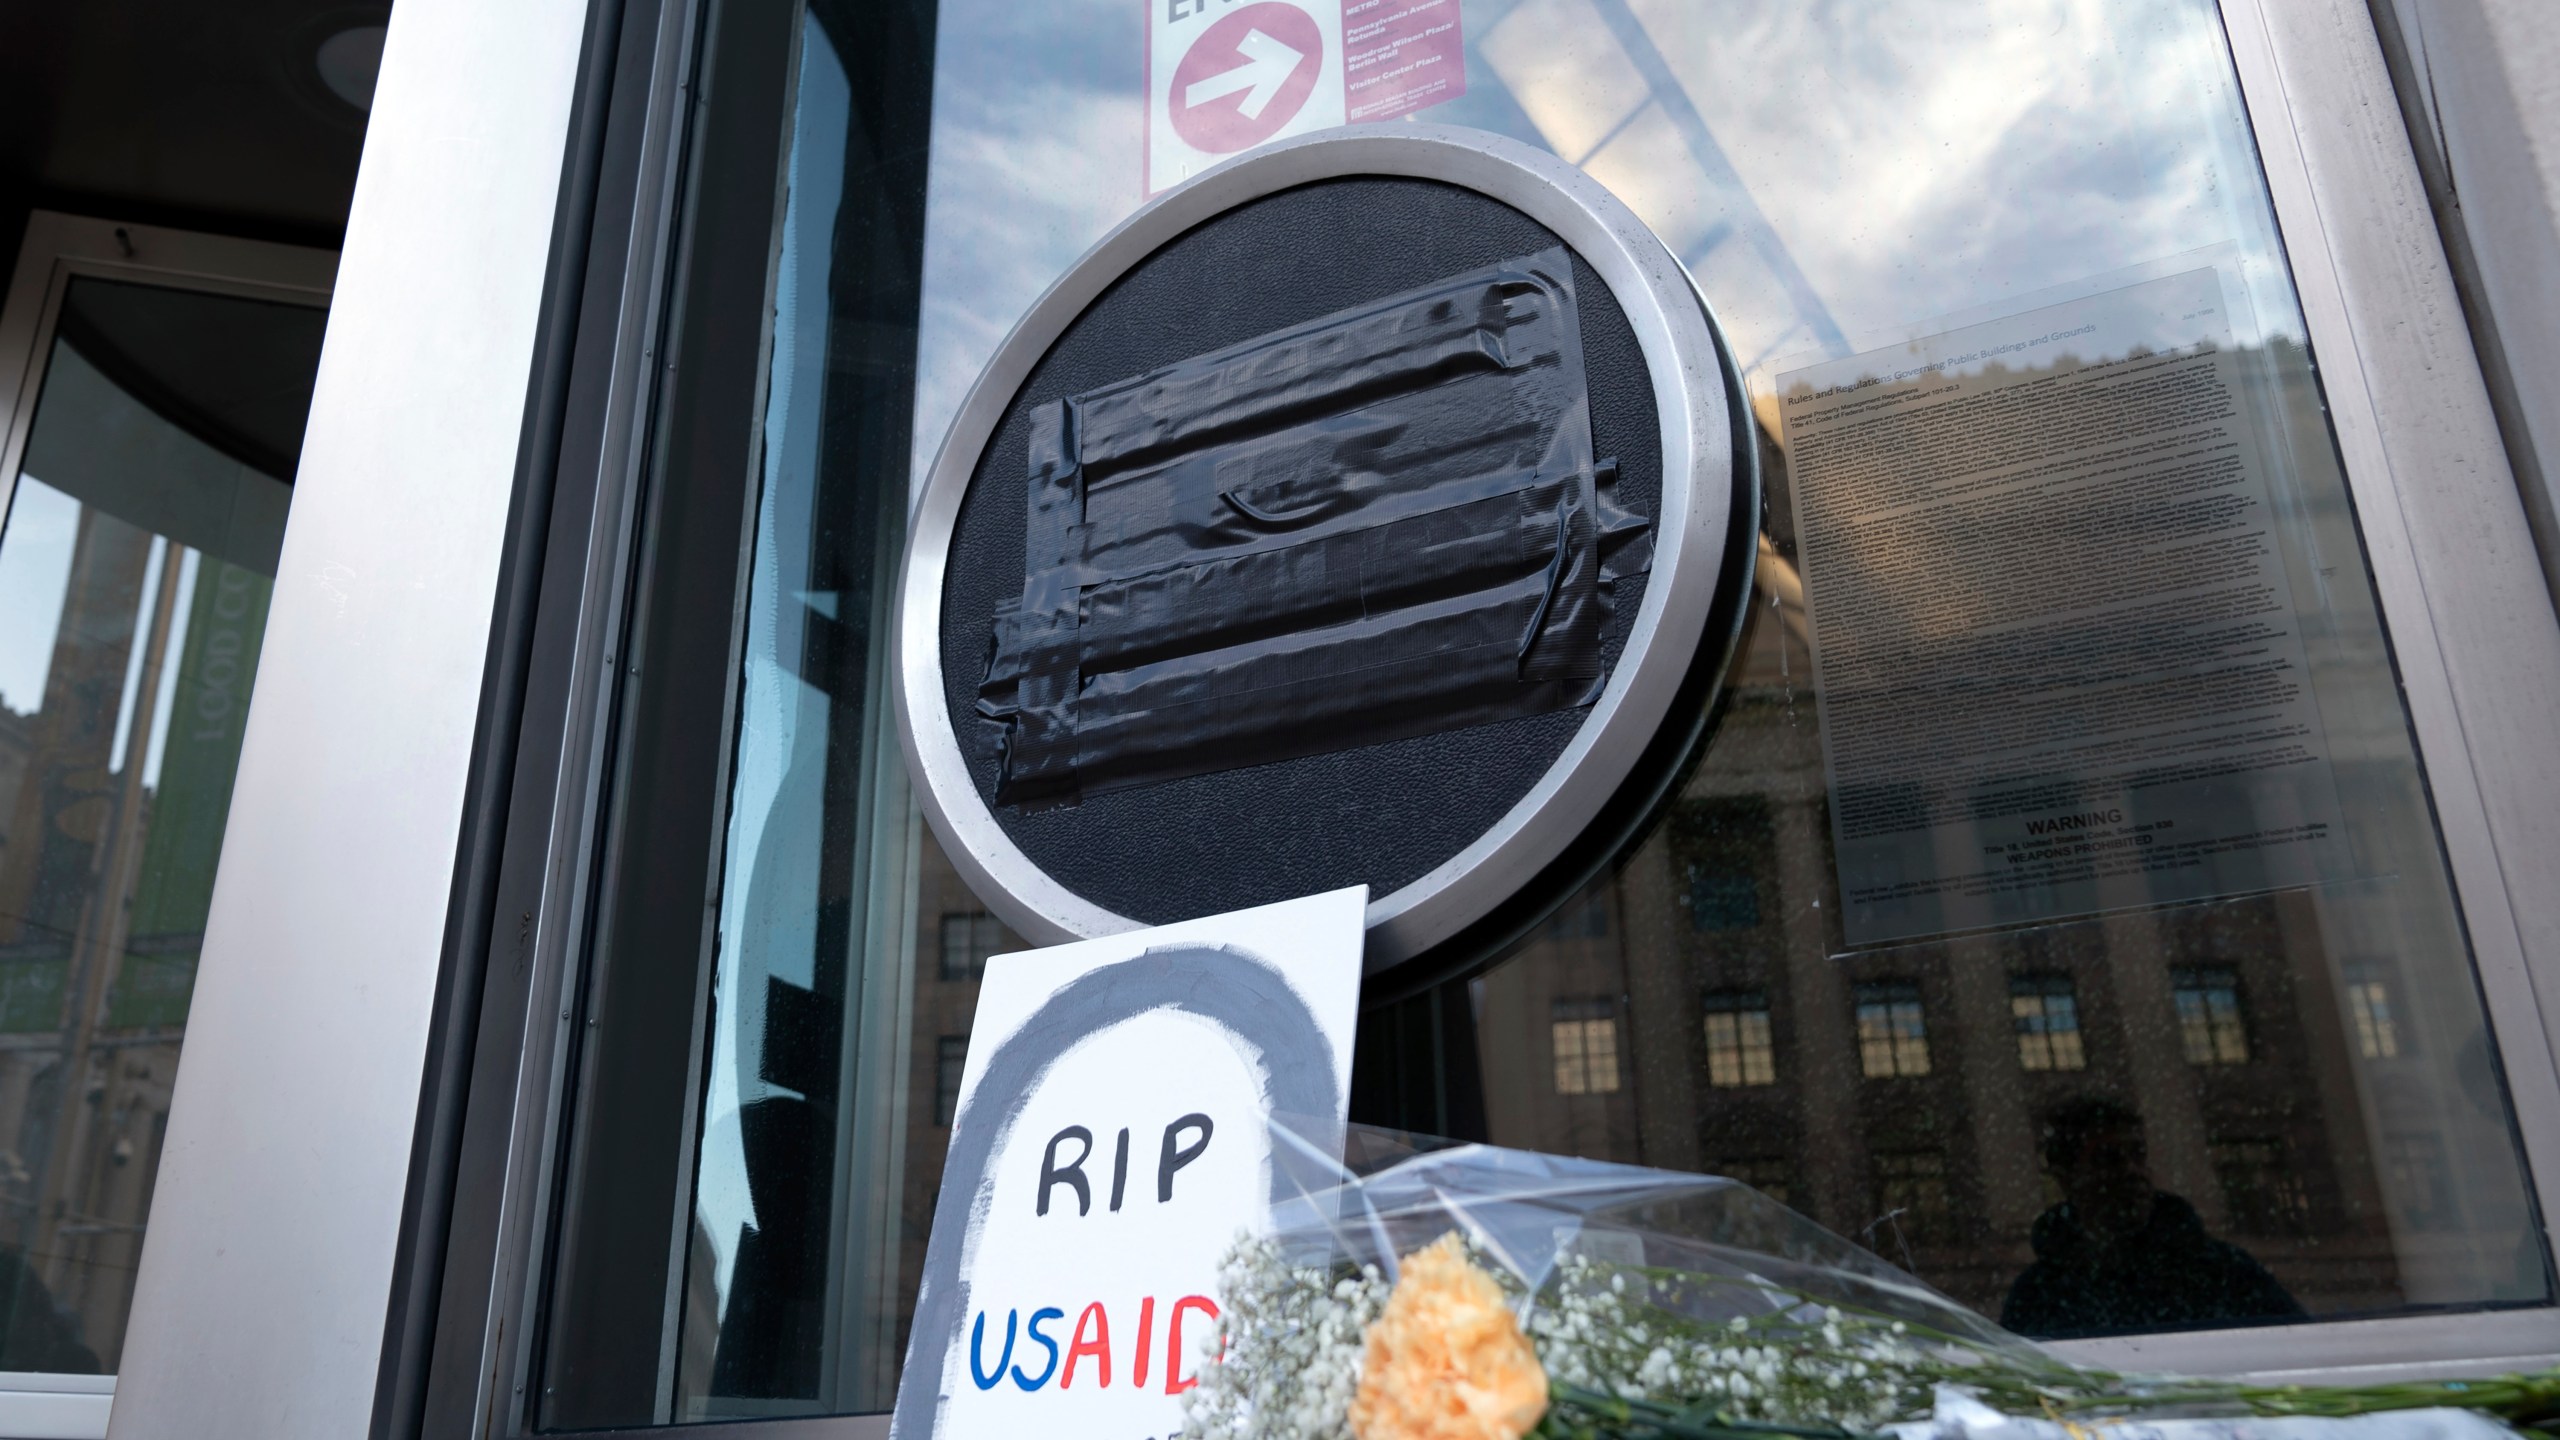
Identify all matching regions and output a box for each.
[545,0,2547,1425]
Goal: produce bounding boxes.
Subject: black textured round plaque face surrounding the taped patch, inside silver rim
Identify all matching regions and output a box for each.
[942,177,1661,922]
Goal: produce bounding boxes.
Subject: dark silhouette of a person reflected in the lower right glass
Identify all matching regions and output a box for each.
[1999,1097,2301,1340]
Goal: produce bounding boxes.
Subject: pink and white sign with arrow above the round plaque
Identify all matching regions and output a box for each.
[1139,0,1467,195]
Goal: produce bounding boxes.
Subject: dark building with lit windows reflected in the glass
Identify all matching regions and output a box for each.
[1472,364,2542,1314]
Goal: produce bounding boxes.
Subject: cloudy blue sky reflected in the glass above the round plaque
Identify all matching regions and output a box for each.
[916,0,2299,482]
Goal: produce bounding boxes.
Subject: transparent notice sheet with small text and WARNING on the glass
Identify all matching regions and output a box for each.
[1777,269,2345,945]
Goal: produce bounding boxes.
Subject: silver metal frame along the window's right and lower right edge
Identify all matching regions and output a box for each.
[2056,0,2560,1381]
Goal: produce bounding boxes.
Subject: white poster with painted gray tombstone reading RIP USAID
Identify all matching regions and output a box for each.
[891,887,1370,1440]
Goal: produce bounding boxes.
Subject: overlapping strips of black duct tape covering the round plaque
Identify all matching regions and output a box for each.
[978,246,1649,805]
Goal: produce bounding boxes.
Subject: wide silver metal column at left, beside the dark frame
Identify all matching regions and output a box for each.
[110,0,589,1440]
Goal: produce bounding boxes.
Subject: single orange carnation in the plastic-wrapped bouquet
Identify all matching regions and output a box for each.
[1352,1232,1546,1440]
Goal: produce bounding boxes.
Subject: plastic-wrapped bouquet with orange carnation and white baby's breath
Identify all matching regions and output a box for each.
[1183,1127,2560,1440]
